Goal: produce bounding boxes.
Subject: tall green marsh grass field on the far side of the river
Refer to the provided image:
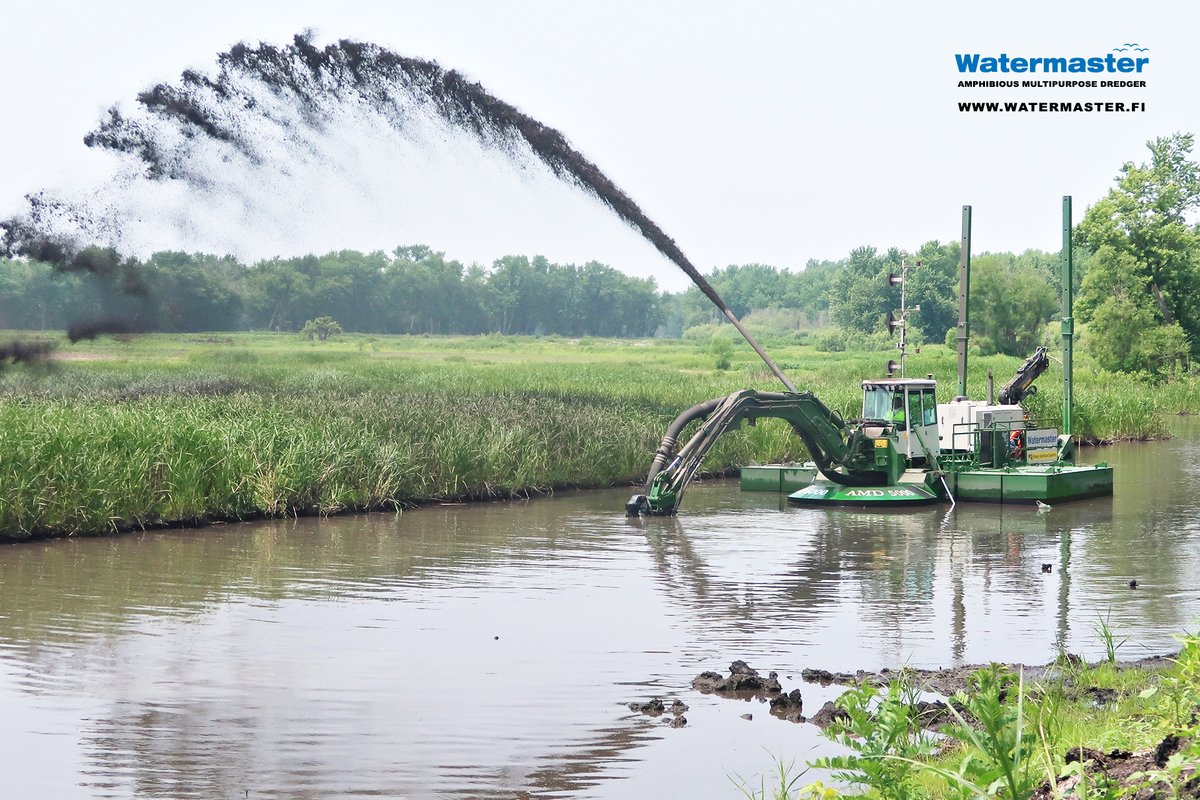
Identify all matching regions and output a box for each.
[0,333,1200,539]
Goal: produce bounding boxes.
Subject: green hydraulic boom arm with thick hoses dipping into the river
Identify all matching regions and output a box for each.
[625,389,904,517]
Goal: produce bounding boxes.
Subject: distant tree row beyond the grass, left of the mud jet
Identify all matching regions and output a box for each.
[0,246,661,337]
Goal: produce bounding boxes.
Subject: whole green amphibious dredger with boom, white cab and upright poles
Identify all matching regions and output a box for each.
[625,197,1112,516]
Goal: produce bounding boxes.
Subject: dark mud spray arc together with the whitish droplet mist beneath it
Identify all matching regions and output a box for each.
[0,36,698,296]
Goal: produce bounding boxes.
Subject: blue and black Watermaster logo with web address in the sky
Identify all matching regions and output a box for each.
[954,42,1151,113]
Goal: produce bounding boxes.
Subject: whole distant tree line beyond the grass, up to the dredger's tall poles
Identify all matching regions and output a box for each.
[0,241,1057,353]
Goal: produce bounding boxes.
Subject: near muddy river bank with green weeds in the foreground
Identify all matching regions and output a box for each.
[692,652,1200,800]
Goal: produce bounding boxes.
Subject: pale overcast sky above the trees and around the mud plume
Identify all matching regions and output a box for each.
[0,0,1200,289]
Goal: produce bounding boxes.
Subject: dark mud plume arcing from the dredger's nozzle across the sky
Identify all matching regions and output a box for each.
[7,35,792,387]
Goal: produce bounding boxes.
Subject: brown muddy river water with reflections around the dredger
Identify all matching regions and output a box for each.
[0,422,1200,798]
